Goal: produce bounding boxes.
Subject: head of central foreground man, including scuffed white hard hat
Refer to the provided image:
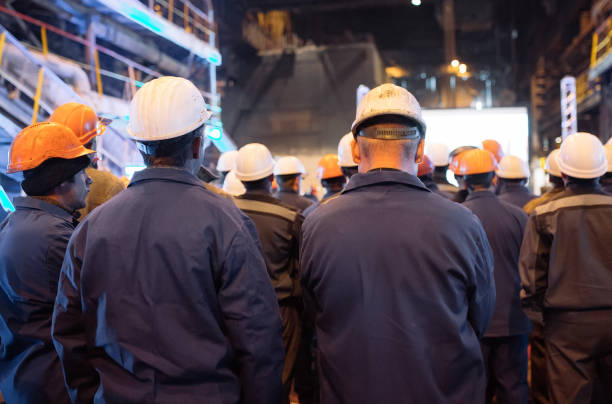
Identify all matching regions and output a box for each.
[351,84,426,175]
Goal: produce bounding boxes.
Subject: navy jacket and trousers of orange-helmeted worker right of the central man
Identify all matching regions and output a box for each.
[463,191,531,404]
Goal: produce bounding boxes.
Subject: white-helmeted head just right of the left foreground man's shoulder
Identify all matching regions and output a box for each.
[234,143,275,192]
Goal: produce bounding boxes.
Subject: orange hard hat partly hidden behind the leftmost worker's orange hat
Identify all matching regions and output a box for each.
[49,102,106,145]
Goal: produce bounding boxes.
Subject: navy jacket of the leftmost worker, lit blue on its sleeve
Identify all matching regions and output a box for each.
[0,197,75,404]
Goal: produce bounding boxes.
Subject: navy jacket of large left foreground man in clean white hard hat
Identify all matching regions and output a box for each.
[53,168,283,404]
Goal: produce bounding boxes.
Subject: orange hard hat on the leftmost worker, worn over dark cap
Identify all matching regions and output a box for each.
[6,122,95,174]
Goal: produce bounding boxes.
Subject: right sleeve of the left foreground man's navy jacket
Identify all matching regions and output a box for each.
[218,217,284,404]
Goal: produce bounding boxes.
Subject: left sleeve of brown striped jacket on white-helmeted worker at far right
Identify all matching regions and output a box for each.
[519,215,550,325]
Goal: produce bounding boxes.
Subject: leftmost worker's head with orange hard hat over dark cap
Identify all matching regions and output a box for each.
[7,122,94,210]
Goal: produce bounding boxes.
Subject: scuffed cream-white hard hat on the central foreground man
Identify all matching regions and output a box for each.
[351,83,426,136]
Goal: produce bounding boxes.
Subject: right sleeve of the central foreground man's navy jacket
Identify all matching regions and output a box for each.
[468,223,495,338]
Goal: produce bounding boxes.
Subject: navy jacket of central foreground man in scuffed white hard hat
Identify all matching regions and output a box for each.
[300,171,495,404]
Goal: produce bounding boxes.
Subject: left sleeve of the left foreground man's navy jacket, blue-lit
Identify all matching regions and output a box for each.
[51,230,100,403]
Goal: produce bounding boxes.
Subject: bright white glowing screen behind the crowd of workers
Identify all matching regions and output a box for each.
[423,107,529,161]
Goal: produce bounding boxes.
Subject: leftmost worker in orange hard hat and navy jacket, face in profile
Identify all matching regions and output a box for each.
[0,123,93,404]
